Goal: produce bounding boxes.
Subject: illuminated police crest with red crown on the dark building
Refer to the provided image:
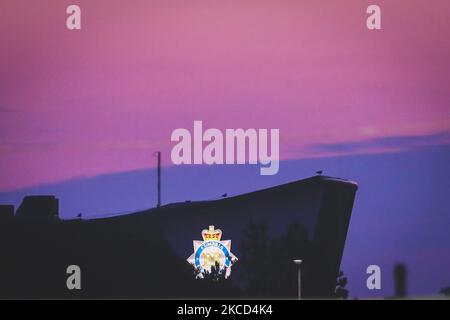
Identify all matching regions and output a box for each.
[187,226,237,278]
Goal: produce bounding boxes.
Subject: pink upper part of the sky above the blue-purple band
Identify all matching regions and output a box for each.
[0,0,450,190]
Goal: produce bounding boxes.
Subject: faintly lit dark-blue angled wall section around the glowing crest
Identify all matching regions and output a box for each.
[154,176,357,297]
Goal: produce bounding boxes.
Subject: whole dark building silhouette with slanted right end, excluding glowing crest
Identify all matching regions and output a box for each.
[0,175,357,298]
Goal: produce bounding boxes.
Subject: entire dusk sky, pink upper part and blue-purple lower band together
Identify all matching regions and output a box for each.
[0,0,450,296]
